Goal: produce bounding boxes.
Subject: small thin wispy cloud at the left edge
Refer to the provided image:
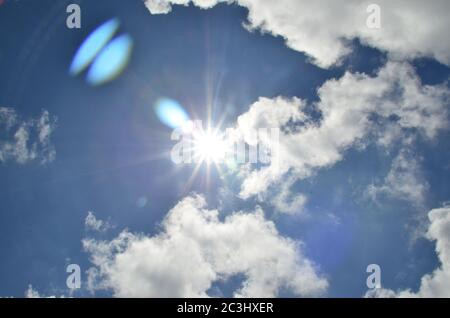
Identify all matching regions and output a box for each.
[0,107,56,164]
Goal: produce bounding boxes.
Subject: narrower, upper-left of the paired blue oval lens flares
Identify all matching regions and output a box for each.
[70,18,120,76]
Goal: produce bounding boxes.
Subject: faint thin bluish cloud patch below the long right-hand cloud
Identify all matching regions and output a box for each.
[366,149,429,208]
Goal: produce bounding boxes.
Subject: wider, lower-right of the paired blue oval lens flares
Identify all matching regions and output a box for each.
[87,34,133,86]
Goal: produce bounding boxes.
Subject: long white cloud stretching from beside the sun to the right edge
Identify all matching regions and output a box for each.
[232,61,450,199]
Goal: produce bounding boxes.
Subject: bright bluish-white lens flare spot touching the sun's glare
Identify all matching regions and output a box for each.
[155,98,189,129]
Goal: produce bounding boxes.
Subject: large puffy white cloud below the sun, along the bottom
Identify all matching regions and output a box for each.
[83,196,328,297]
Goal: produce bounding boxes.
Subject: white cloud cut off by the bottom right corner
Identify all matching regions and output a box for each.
[366,206,450,298]
